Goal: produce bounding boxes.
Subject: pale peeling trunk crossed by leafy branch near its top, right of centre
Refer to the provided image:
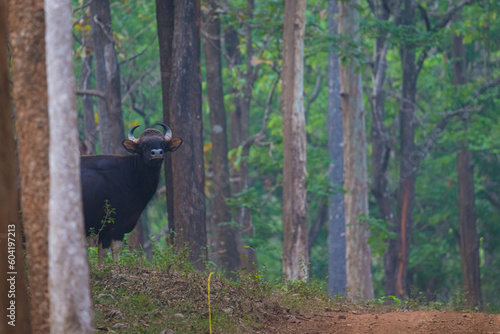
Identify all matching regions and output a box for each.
[338,0,373,299]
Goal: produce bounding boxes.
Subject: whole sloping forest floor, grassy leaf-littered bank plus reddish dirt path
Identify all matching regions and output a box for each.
[91,252,500,334]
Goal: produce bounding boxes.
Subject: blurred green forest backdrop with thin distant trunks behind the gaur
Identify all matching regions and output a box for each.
[68,0,500,303]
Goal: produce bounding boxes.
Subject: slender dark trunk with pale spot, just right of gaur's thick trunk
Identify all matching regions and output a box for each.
[204,0,239,278]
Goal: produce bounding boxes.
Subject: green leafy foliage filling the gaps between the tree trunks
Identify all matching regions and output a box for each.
[73,0,500,308]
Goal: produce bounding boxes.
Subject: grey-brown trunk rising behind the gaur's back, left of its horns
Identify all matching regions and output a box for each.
[90,0,125,154]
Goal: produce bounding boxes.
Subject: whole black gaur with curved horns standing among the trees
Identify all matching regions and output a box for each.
[80,123,182,266]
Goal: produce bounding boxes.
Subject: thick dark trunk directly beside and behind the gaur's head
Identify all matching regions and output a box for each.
[157,0,207,269]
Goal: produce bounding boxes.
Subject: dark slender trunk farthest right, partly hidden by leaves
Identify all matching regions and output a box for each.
[451,34,481,307]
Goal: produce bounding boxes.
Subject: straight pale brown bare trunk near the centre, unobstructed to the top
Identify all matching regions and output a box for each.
[281,0,309,280]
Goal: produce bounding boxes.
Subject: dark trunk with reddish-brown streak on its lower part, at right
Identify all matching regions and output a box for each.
[394,0,422,298]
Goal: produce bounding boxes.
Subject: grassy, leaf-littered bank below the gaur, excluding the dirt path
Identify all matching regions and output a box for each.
[89,246,496,334]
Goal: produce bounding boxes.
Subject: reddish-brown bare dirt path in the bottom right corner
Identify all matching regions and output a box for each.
[260,312,500,334]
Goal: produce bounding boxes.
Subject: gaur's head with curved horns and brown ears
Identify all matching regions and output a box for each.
[122,123,182,167]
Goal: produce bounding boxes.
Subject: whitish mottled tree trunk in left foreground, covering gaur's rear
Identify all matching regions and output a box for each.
[45,0,94,334]
